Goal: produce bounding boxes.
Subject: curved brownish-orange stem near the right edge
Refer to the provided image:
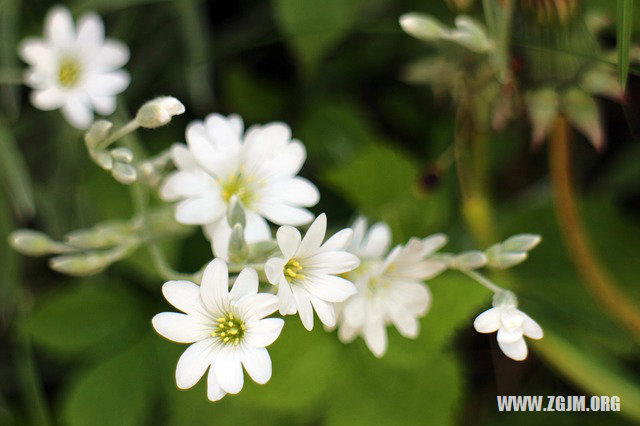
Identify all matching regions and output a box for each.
[549,116,640,338]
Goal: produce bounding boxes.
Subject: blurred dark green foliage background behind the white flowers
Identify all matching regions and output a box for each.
[0,0,640,426]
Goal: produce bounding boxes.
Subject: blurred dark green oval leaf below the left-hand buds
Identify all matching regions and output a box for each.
[23,279,141,357]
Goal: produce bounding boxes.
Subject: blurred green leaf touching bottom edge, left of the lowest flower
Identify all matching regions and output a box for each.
[61,337,156,426]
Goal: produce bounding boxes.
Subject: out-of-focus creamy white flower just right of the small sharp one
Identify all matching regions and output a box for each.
[338,218,446,357]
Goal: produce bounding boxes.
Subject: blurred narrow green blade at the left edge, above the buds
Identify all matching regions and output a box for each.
[0,117,35,218]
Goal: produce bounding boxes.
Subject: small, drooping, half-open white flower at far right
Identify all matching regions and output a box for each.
[473,293,543,361]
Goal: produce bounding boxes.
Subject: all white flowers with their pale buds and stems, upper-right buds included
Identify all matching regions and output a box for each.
[6,7,542,401]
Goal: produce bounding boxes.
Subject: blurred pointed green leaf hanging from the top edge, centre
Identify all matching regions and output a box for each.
[274,0,363,72]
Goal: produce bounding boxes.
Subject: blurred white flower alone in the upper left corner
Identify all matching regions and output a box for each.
[19,6,129,129]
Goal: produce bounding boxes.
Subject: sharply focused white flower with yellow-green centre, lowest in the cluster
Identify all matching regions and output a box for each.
[152,259,284,401]
